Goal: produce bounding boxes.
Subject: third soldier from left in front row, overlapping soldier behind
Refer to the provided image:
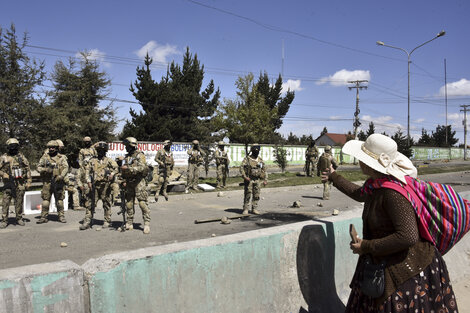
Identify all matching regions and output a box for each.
[80,141,118,230]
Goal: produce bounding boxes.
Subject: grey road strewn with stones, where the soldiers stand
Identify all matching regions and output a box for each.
[0,165,470,313]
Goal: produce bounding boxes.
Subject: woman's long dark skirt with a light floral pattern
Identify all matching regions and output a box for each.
[346,251,458,313]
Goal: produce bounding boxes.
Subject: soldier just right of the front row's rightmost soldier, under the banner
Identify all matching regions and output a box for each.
[155,140,175,201]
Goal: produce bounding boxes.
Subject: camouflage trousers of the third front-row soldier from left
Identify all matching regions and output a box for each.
[83,182,112,224]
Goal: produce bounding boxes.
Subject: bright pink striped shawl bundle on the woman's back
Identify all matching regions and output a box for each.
[361,176,470,255]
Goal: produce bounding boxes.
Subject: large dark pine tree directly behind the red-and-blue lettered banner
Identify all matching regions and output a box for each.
[121,48,220,142]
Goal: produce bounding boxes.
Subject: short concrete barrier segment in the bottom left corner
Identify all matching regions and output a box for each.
[0,260,89,313]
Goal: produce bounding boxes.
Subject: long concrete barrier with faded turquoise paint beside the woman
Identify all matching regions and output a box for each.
[83,212,361,313]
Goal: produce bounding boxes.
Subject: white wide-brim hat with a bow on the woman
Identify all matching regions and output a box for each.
[342,134,418,184]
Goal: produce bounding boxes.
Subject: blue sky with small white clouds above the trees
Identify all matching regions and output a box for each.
[0,0,470,143]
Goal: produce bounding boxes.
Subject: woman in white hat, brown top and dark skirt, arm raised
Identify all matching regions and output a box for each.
[322,134,458,312]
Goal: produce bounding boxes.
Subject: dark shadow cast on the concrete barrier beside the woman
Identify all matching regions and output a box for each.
[297,220,345,313]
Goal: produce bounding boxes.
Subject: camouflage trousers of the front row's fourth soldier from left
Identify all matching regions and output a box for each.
[124,178,150,225]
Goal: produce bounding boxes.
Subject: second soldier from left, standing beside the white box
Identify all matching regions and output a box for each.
[36,140,69,224]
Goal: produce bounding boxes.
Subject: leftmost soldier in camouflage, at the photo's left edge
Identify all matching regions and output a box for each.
[0,138,31,228]
